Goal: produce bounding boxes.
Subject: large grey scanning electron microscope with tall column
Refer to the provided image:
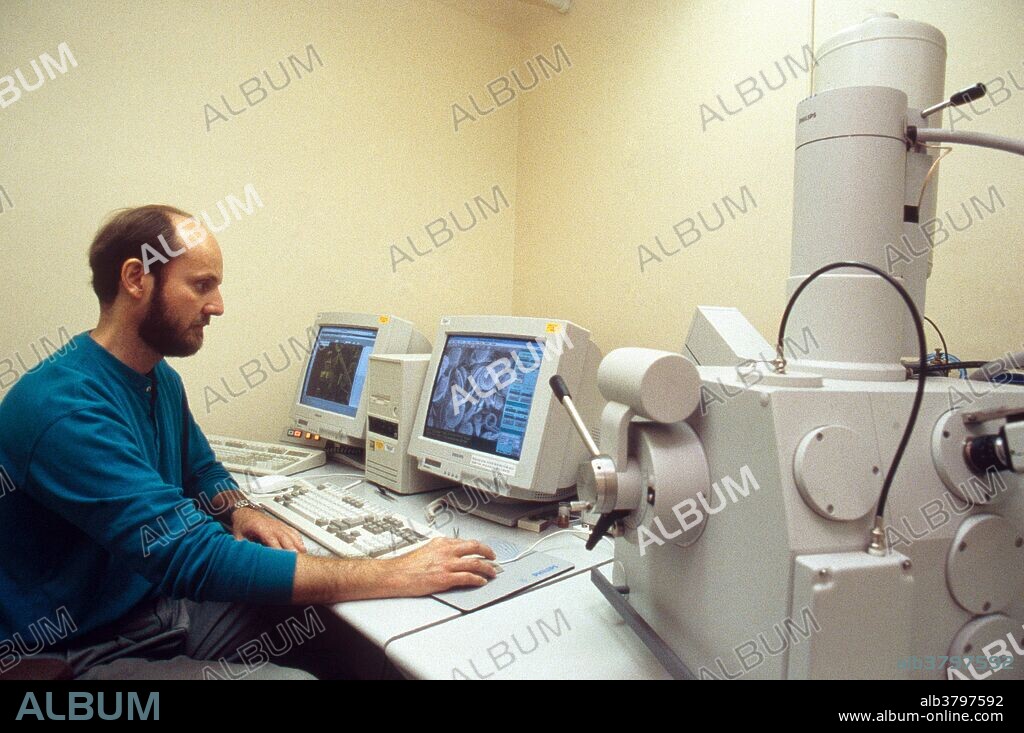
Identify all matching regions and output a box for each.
[552,14,1024,679]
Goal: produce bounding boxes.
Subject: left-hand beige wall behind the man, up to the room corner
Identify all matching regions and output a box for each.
[0,0,519,438]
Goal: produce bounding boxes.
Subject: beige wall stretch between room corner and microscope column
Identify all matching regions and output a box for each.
[515,0,810,351]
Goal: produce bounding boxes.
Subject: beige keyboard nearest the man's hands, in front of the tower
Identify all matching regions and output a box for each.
[254,479,444,558]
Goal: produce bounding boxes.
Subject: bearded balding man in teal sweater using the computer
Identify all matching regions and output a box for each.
[0,206,496,679]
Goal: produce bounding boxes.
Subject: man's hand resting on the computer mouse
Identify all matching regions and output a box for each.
[381,537,498,596]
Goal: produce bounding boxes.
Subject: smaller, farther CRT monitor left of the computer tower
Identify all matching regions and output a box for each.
[286,313,430,447]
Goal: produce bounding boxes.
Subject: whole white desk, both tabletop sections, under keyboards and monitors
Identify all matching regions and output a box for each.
[237,464,667,679]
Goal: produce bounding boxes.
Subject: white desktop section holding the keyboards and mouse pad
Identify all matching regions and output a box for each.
[236,463,614,649]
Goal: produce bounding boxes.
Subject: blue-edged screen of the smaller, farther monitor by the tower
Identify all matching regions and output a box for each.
[299,326,377,418]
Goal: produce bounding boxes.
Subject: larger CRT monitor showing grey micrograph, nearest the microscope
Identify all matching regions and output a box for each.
[409,315,601,502]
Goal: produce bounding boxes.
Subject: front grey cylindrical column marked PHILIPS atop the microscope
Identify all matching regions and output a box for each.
[786,87,906,381]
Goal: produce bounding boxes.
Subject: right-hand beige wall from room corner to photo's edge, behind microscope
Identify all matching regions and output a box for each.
[515,0,1024,357]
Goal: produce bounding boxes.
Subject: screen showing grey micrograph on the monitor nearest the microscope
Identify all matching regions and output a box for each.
[423,335,543,461]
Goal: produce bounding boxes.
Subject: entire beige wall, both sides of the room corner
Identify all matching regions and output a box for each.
[0,0,1024,438]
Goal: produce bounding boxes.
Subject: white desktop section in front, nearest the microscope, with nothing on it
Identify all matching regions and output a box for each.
[386,563,671,680]
